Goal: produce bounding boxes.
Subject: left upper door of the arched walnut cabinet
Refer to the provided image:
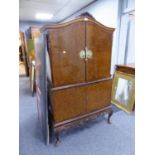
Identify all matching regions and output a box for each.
[49,22,85,86]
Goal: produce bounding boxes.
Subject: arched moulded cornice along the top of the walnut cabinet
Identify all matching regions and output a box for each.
[40,16,115,32]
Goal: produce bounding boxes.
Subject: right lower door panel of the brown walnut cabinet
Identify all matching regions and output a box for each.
[86,80,112,112]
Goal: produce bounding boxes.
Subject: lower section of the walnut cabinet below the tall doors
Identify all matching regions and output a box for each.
[50,79,112,145]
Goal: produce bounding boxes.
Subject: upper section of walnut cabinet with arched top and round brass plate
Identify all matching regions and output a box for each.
[41,16,114,87]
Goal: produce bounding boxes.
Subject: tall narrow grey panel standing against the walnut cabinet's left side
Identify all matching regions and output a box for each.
[35,34,49,144]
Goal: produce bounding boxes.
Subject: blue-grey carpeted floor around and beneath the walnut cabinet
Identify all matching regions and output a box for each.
[19,77,135,155]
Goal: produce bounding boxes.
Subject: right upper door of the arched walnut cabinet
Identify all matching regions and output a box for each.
[86,21,112,81]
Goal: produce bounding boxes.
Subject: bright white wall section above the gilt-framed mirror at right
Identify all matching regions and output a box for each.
[117,0,135,64]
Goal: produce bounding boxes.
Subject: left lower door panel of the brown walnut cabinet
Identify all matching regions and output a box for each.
[52,87,86,123]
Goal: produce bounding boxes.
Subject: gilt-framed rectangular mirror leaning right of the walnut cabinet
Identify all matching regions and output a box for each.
[111,71,135,114]
